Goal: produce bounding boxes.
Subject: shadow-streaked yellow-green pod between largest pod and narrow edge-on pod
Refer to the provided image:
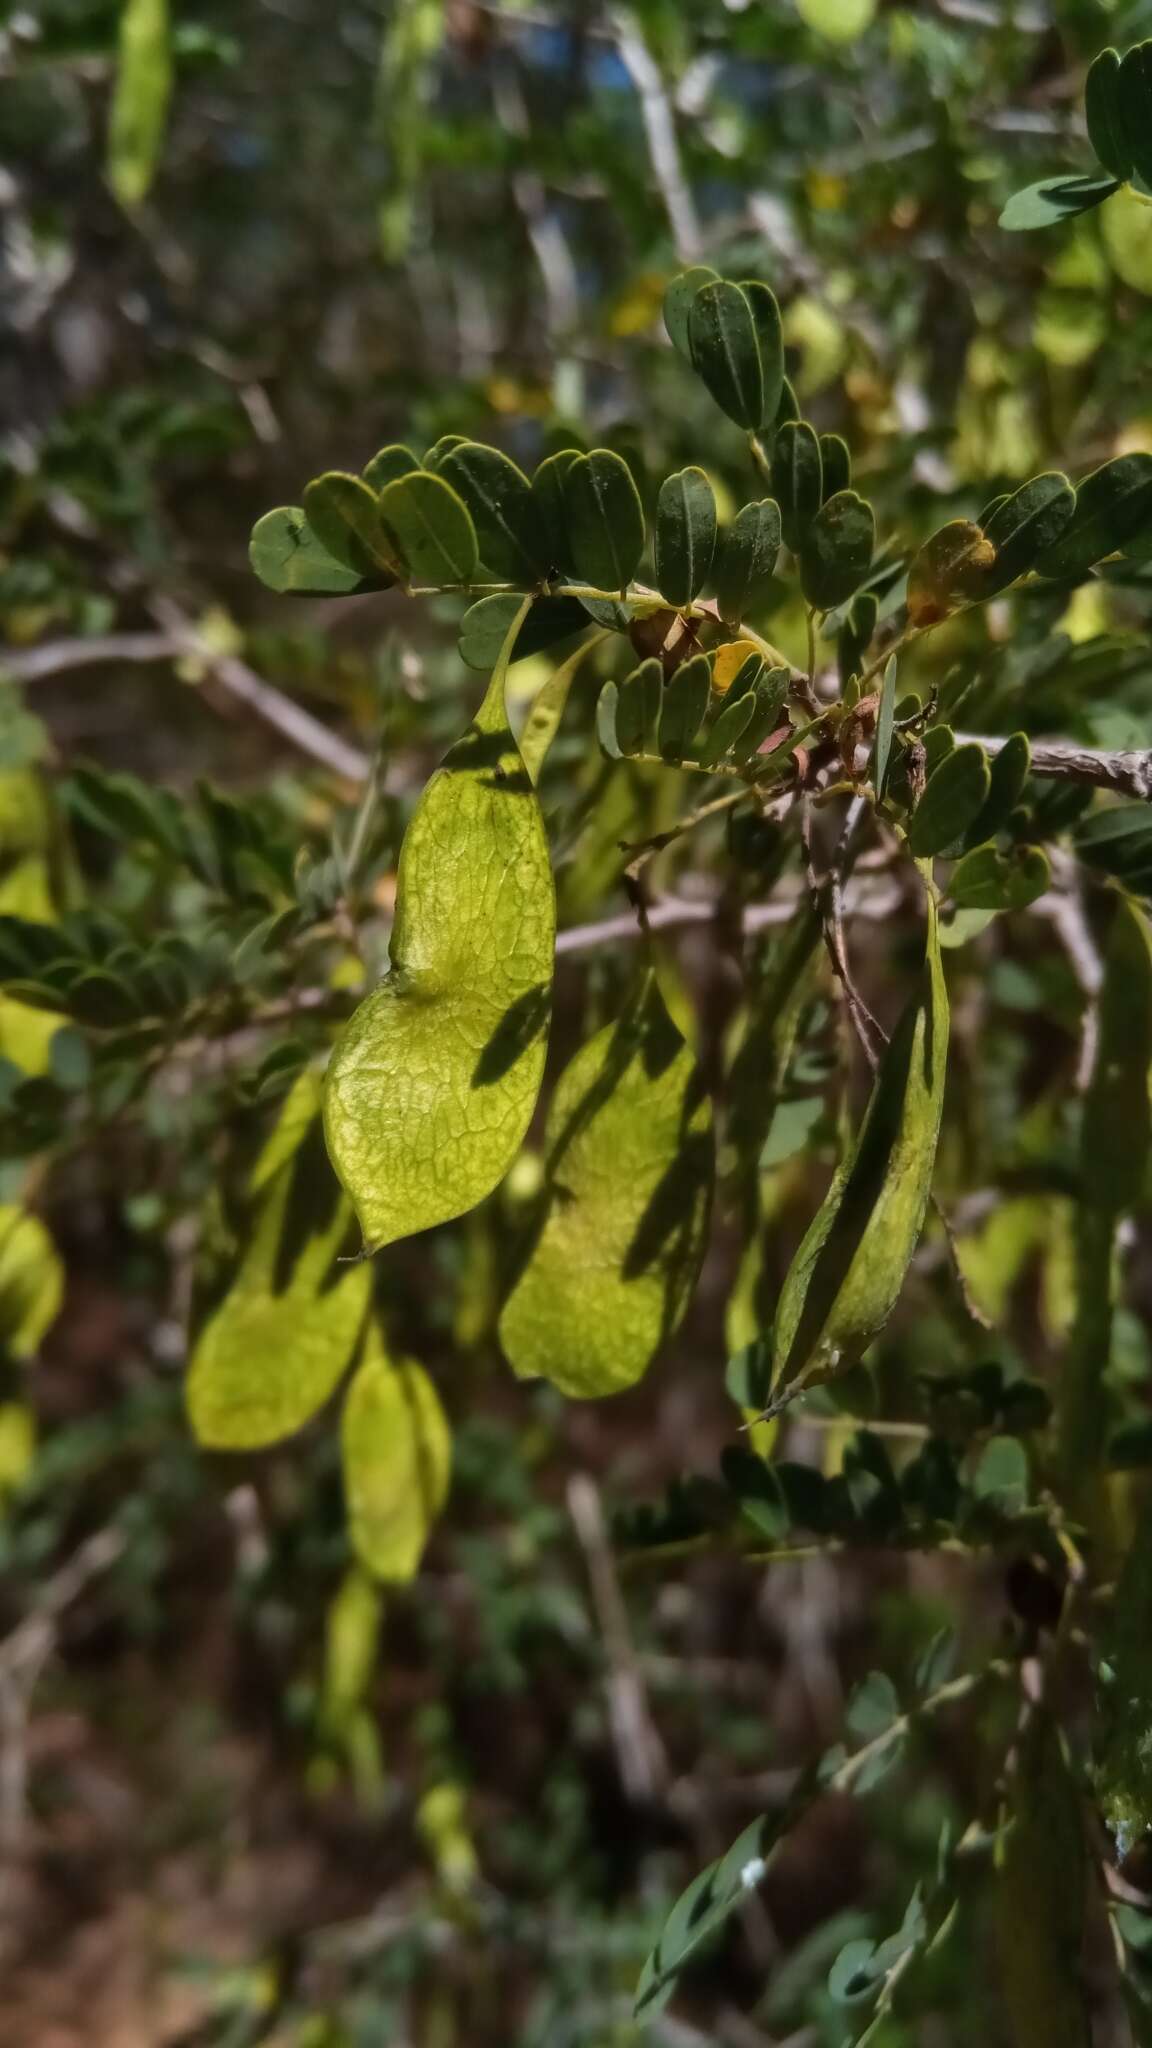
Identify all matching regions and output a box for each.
[500,973,713,1397]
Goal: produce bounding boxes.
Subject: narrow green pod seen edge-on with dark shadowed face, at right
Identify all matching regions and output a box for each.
[773,897,949,1405]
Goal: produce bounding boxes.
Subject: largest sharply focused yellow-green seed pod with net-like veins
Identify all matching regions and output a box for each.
[324,602,556,1251]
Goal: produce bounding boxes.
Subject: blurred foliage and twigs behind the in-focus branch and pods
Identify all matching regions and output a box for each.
[0,0,1152,2048]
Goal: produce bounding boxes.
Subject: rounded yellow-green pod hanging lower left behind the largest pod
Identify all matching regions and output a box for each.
[187,1141,371,1450]
